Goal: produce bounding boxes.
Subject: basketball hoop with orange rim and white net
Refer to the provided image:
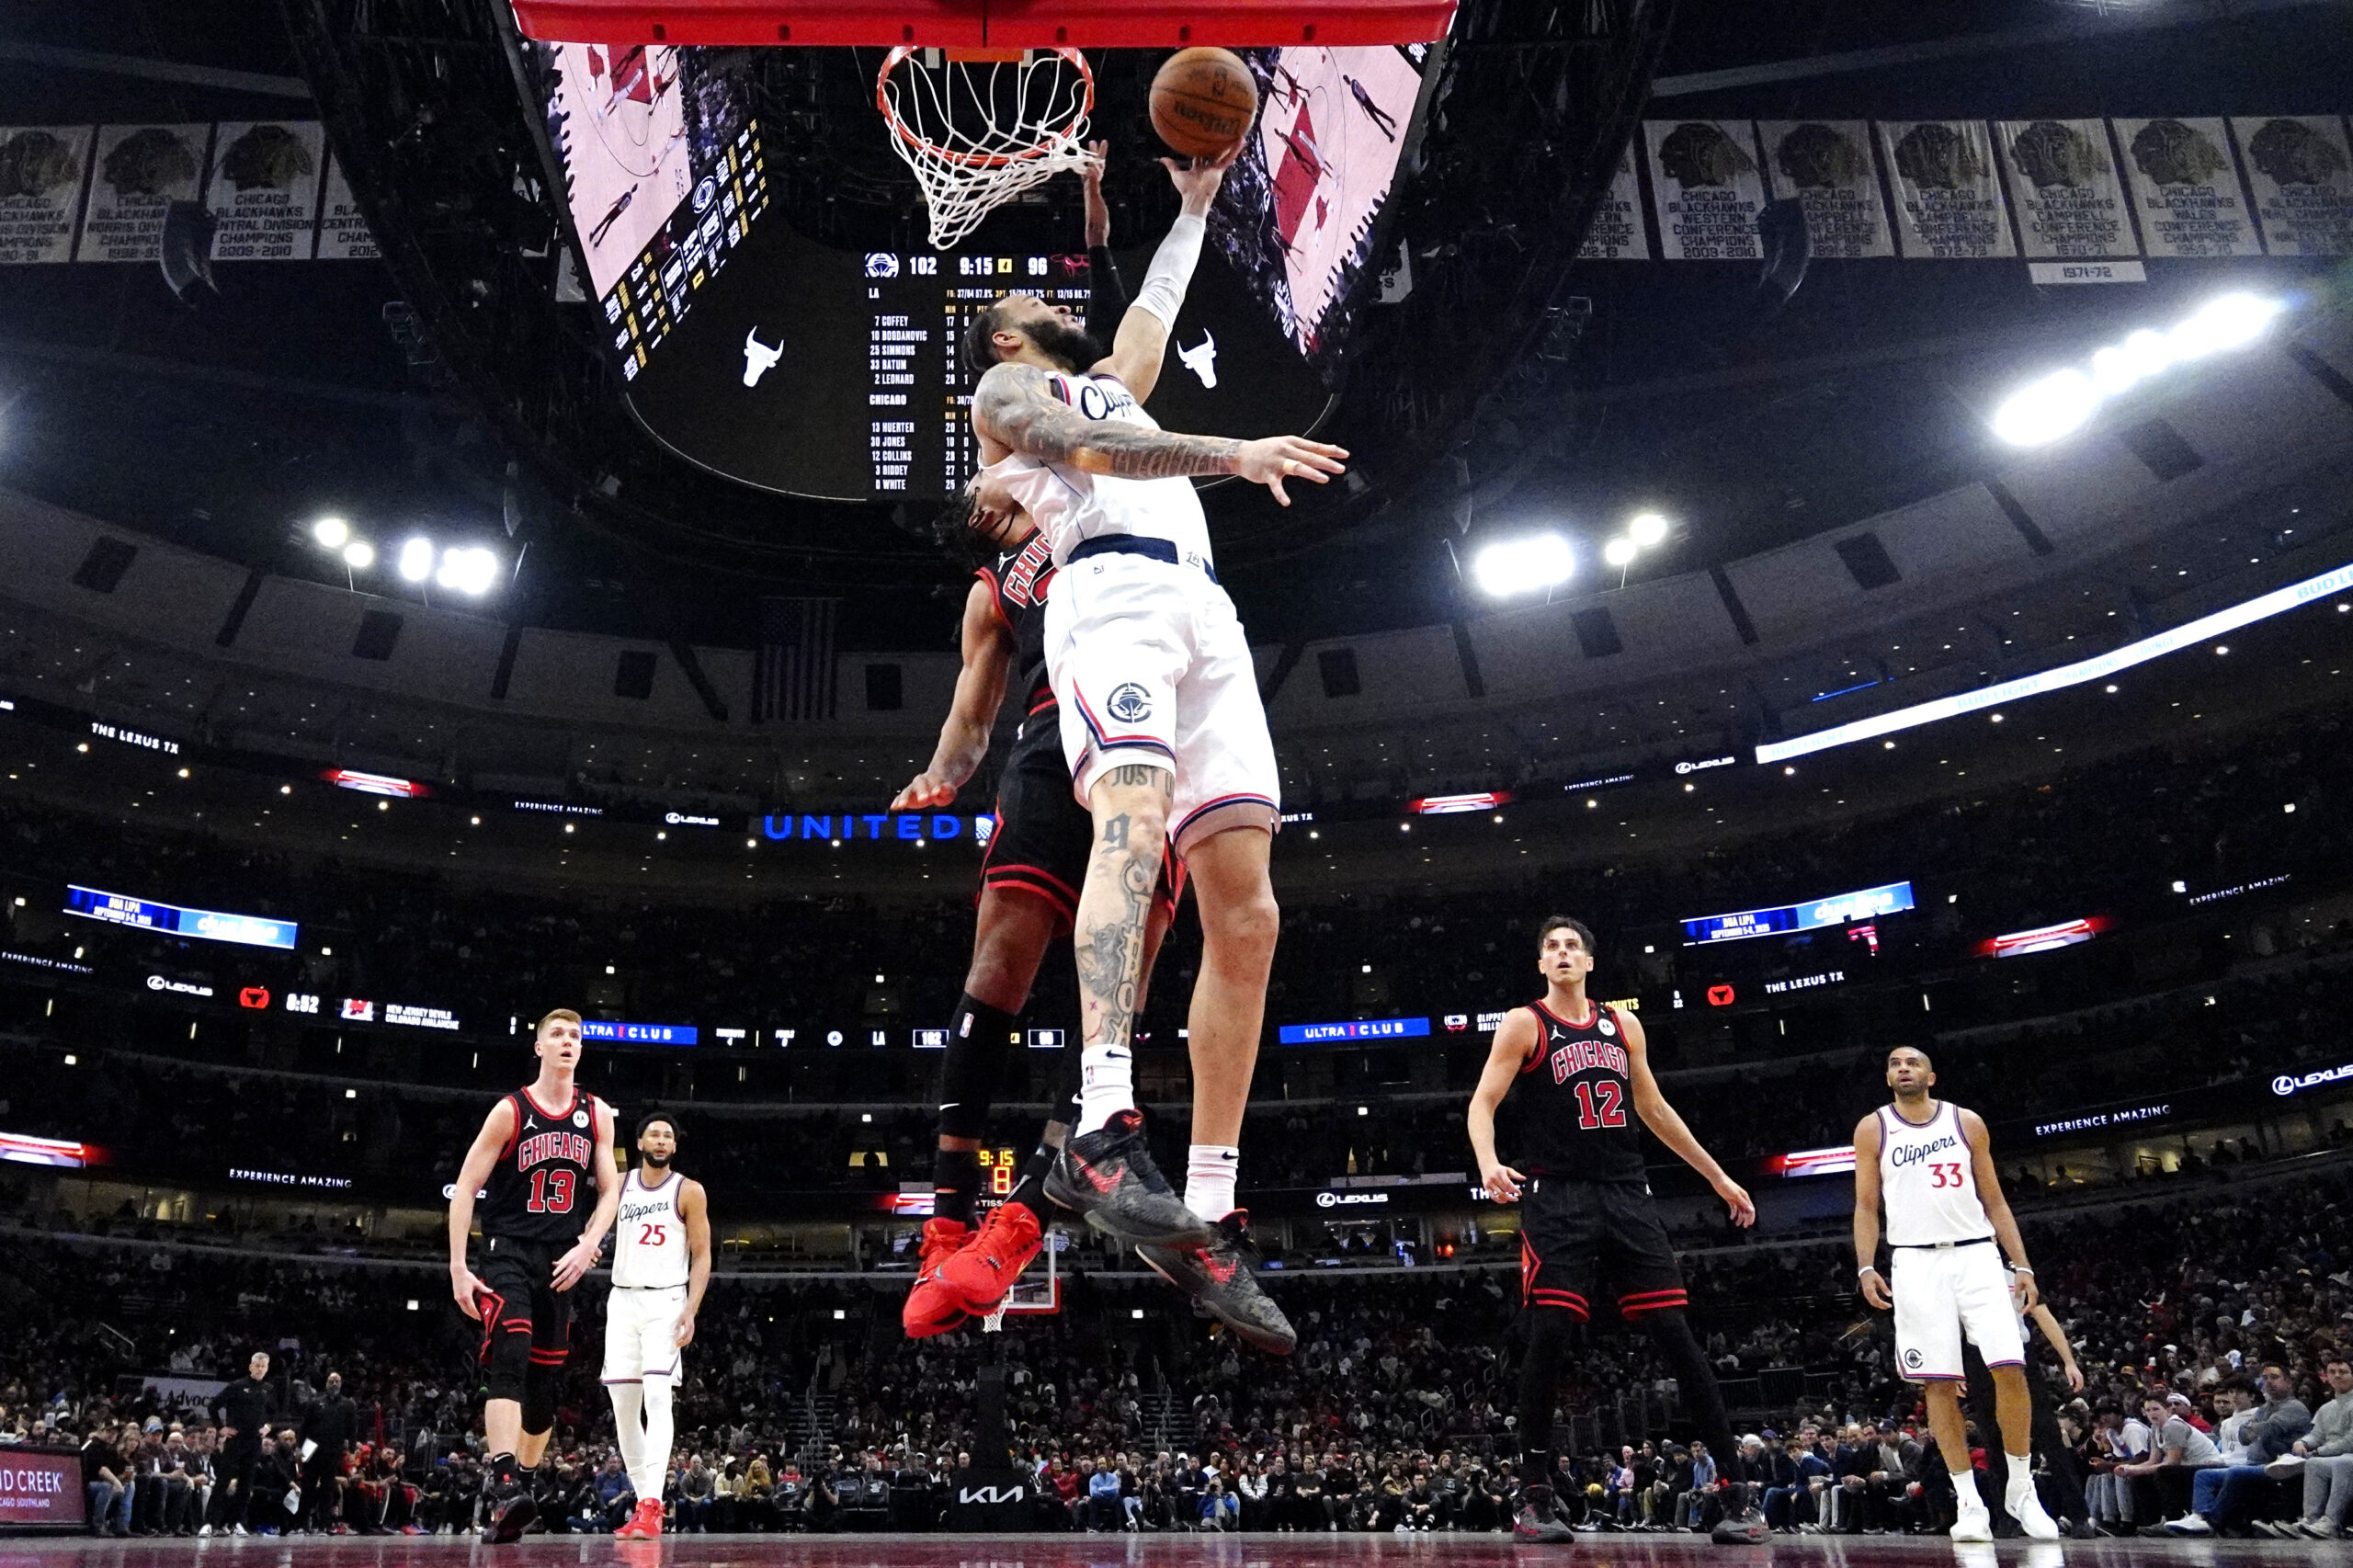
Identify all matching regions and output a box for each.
[875,45,1094,250]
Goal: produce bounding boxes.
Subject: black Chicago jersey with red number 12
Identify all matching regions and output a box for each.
[1511,1003,1644,1182]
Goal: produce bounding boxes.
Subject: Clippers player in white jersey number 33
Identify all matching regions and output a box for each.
[1854,1045,2059,1540]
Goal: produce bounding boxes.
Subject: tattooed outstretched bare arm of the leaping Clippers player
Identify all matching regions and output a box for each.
[972,362,1348,506]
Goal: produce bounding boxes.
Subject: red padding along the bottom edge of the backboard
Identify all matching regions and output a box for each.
[513,0,1457,50]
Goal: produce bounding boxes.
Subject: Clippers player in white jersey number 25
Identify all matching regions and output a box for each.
[605,1111,710,1540]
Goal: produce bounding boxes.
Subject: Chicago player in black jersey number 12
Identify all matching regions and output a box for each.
[1468,915,1768,1544]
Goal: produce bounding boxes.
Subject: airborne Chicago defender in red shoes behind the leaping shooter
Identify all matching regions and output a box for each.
[890,142,1207,1340]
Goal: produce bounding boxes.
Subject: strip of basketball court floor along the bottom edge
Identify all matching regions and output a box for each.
[0,1535,2344,1568]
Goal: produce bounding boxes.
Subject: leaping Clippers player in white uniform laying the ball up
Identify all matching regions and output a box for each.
[965,143,1346,1354]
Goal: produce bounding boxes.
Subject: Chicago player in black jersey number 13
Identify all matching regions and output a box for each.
[449,1007,621,1542]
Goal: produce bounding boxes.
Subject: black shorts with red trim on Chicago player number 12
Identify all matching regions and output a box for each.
[1520,1175,1692,1321]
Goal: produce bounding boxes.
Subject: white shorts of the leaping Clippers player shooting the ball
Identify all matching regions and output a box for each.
[1045,553,1282,855]
